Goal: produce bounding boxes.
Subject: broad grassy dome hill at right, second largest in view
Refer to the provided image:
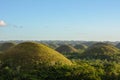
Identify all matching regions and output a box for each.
[82,43,119,59]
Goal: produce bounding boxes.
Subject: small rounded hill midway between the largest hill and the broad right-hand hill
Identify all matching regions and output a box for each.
[56,45,77,53]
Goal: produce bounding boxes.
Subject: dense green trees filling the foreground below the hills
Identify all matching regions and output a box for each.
[0,60,120,80]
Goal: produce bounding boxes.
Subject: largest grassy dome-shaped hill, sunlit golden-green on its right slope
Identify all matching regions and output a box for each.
[2,42,72,68]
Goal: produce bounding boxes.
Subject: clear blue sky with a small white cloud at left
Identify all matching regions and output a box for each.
[0,0,120,41]
